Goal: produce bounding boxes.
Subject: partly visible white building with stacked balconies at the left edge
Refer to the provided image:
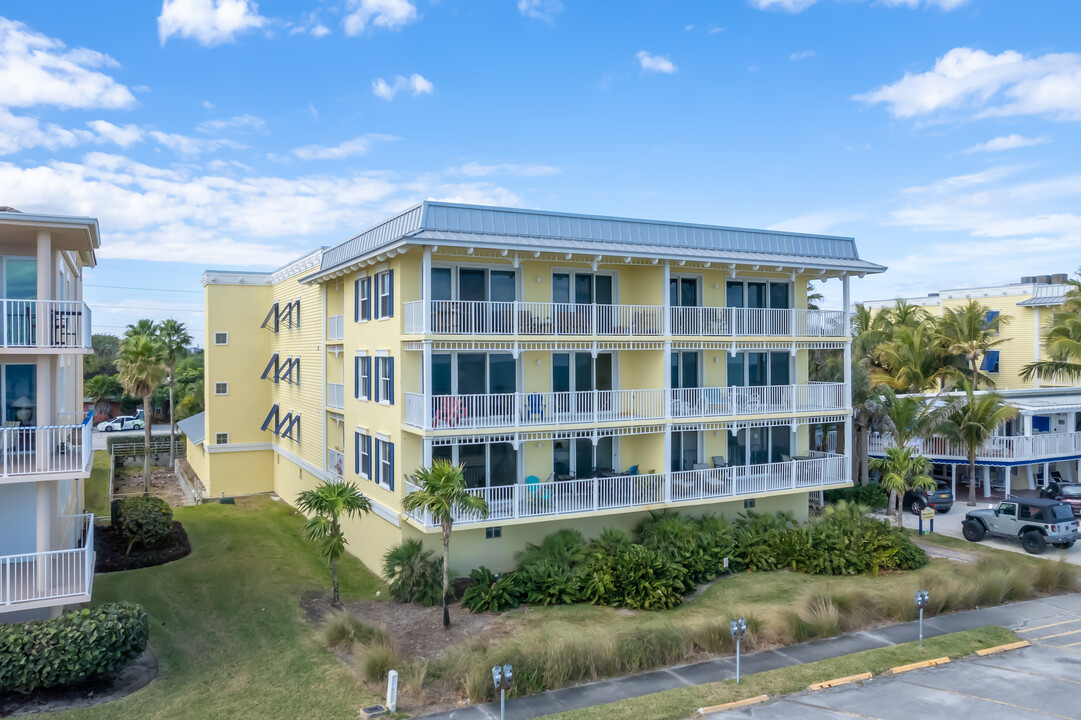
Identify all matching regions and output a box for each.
[0,208,101,623]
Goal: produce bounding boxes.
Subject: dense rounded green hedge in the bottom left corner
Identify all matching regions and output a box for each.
[0,602,150,695]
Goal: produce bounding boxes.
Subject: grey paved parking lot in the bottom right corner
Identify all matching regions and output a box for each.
[710,640,1081,720]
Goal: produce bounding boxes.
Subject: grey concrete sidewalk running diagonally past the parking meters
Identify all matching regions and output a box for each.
[423,595,1081,720]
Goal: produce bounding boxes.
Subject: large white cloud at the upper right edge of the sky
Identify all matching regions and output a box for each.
[853,48,1081,120]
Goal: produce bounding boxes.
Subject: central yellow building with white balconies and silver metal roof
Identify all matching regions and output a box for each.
[184,202,884,573]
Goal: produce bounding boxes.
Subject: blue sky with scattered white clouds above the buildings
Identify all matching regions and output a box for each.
[0,0,1081,334]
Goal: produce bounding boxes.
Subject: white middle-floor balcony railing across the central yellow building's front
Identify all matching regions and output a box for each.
[405,383,848,430]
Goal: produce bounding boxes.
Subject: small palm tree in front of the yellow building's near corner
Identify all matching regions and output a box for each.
[402,459,488,630]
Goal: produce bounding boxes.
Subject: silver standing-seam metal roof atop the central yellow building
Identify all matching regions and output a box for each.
[309,201,885,279]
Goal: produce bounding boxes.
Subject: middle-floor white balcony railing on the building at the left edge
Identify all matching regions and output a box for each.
[0,418,94,477]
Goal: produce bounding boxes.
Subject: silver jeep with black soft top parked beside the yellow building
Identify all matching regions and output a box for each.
[962,497,1081,555]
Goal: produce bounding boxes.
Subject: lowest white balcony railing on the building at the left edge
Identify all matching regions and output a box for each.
[0,515,94,610]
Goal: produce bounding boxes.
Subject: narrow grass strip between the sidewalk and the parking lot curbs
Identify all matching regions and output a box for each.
[544,627,1017,720]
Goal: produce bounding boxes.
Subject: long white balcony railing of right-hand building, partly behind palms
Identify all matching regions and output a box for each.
[867,432,1081,463]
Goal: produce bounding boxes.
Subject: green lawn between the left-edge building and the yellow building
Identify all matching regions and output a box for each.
[57,496,383,720]
